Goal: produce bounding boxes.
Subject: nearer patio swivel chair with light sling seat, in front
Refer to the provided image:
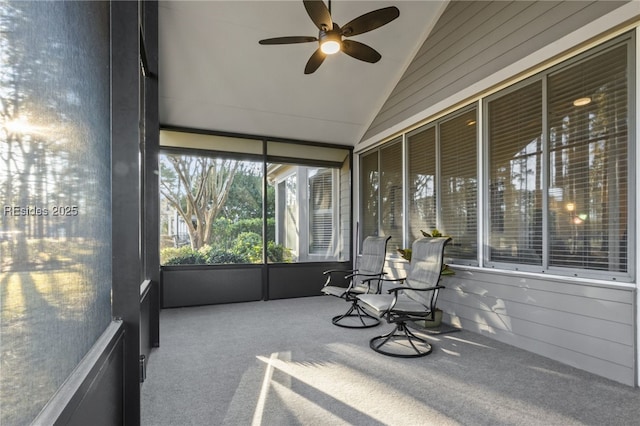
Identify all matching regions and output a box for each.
[358,237,451,358]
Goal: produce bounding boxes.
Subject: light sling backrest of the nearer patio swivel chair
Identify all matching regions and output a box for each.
[404,237,451,309]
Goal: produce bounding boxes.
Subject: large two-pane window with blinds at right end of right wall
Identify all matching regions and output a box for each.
[486,37,629,276]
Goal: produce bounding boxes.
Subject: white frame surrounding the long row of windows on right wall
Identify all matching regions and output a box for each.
[358,31,638,283]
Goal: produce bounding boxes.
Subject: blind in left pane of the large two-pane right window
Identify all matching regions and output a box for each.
[488,80,543,265]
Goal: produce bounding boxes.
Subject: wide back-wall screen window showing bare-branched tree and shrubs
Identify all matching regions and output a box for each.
[159,152,274,265]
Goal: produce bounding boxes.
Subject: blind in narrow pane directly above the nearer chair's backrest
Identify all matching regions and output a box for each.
[407,126,437,246]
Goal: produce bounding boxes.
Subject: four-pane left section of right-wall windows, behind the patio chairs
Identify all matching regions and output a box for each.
[361,108,478,265]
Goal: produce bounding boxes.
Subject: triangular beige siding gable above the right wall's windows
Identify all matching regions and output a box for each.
[363,1,626,140]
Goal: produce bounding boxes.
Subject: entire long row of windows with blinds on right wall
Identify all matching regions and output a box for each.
[360,35,635,280]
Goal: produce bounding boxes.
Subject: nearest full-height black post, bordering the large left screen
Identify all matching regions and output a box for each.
[110,1,143,426]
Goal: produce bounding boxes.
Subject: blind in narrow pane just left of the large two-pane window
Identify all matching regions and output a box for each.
[439,108,478,264]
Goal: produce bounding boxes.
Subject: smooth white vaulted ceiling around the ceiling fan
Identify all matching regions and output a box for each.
[158,0,445,145]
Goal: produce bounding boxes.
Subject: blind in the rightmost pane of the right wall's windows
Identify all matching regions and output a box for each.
[548,44,628,271]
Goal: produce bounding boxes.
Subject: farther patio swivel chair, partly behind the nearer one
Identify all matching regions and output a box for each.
[322,236,391,328]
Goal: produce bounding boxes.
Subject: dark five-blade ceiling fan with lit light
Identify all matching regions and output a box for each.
[258,0,400,74]
